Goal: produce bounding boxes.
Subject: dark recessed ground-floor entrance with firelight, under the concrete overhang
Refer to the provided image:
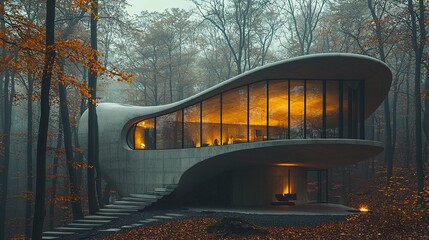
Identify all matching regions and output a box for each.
[178,165,329,206]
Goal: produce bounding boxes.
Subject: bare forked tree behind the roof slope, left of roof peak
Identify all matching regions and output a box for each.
[192,0,277,74]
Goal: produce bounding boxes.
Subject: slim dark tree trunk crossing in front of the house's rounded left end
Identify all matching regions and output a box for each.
[88,0,100,214]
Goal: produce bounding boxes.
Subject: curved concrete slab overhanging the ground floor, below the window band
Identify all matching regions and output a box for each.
[176,139,383,193]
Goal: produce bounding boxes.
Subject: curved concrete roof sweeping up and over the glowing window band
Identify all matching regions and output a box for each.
[117,53,392,125]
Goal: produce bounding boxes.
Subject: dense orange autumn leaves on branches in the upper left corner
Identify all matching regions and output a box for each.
[0,0,134,100]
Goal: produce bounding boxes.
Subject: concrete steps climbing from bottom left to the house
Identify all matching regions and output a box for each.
[42,184,177,239]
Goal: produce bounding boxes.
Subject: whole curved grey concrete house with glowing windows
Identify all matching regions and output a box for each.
[79,54,392,205]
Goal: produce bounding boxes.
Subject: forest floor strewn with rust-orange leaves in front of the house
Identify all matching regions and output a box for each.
[101,168,429,240]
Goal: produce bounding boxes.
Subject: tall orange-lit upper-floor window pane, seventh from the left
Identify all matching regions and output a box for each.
[268,80,289,140]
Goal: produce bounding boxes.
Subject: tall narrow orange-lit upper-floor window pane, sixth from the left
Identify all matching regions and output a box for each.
[249,82,267,142]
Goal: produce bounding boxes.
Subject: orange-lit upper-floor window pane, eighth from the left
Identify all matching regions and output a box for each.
[290,80,305,139]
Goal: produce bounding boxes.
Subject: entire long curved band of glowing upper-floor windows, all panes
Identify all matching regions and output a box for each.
[127,79,365,150]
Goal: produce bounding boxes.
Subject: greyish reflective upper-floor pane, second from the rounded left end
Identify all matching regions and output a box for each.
[156,110,182,149]
